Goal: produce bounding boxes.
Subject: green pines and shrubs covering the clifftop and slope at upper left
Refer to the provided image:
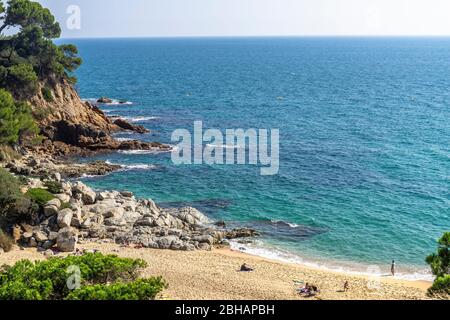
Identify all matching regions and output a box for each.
[0,0,81,145]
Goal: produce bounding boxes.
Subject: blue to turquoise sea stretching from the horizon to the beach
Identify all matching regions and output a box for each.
[62,38,450,278]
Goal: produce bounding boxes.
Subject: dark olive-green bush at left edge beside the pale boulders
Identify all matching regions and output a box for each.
[0,168,37,228]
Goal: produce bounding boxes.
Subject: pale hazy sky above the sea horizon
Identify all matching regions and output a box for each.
[39,0,450,37]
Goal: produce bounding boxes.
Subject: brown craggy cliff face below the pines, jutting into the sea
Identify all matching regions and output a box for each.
[29,82,168,155]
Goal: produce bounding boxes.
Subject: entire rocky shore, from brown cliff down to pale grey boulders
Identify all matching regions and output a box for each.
[0,81,258,255]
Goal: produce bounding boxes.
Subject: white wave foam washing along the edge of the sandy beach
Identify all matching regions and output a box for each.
[230,240,434,281]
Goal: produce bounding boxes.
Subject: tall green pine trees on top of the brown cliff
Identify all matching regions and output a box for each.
[0,0,81,100]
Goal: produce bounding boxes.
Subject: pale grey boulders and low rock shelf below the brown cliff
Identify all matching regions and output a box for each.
[3,152,258,256]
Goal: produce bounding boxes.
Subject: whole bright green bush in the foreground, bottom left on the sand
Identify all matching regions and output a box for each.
[0,253,167,300]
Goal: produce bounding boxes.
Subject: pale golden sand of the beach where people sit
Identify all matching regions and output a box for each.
[0,243,431,300]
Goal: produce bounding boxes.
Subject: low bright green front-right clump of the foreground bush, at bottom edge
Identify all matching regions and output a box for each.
[66,277,167,300]
